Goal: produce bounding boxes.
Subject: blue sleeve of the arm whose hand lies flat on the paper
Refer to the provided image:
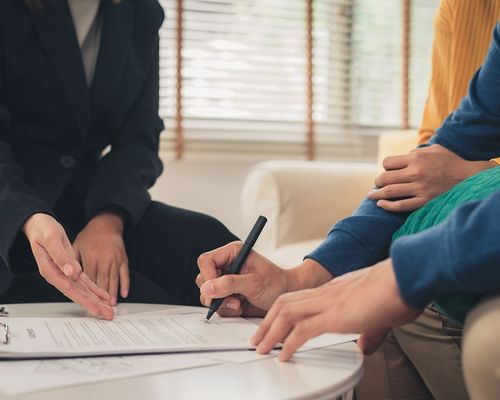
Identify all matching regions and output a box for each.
[390,191,500,308]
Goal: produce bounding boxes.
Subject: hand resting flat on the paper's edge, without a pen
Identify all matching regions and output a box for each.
[252,259,421,361]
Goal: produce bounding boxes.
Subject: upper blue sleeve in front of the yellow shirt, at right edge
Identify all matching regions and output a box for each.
[429,24,500,161]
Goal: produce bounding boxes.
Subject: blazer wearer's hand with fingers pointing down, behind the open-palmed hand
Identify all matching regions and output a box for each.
[73,212,130,305]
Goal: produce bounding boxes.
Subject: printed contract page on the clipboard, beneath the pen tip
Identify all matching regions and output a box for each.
[0,313,256,359]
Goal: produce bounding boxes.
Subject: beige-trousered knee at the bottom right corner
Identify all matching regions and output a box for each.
[462,297,500,399]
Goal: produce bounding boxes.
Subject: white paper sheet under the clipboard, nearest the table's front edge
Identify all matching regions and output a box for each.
[0,354,217,397]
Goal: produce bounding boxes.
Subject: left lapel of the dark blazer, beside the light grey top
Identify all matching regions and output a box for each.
[32,0,90,135]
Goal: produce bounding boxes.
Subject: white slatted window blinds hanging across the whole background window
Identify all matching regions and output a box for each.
[160,0,435,158]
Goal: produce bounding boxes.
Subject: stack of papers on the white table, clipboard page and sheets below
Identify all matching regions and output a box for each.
[0,309,357,395]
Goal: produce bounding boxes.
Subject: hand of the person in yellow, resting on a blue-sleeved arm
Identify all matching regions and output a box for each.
[368,144,497,212]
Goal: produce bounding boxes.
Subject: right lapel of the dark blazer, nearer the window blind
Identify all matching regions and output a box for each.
[90,0,134,118]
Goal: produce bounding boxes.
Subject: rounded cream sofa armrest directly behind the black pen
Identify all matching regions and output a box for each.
[241,161,377,253]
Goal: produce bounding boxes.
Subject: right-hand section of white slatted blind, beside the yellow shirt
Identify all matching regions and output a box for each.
[351,0,438,127]
